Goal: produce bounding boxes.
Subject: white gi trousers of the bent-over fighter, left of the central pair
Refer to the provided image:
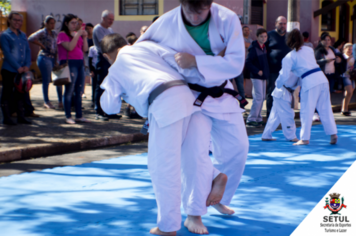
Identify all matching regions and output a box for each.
[148,112,213,232]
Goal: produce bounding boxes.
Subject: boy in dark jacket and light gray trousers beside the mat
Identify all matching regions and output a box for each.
[245,29,269,127]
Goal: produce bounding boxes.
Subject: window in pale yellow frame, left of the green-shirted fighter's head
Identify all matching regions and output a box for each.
[120,0,158,16]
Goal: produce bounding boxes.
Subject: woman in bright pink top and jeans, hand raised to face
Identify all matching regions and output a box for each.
[57,14,89,124]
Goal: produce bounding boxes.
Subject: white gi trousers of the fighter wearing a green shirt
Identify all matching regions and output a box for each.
[182,112,249,216]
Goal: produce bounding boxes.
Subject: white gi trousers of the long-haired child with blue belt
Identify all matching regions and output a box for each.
[300,83,337,140]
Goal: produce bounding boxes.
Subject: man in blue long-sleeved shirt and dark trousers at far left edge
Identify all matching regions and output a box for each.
[0,12,31,125]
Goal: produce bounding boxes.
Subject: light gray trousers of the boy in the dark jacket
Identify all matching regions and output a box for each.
[247,78,266,122]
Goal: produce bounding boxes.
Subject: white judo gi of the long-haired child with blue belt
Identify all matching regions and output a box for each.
[276,46,337,140]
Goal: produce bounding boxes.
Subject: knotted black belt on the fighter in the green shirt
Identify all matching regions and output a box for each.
[188,81,248,108]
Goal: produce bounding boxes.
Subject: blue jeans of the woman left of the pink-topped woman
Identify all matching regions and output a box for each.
[37,55,62,103]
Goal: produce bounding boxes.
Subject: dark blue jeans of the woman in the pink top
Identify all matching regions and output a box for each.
[60,60,85,118]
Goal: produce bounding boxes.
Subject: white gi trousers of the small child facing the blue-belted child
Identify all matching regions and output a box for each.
[262,97,297,140]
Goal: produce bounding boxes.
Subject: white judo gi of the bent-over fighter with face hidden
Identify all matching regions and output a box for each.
[100,41,213,232]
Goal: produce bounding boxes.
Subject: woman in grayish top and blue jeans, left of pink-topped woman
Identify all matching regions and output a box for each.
[28,15,63,109]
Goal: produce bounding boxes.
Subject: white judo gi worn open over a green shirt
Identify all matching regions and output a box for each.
[138,3,249,215]
